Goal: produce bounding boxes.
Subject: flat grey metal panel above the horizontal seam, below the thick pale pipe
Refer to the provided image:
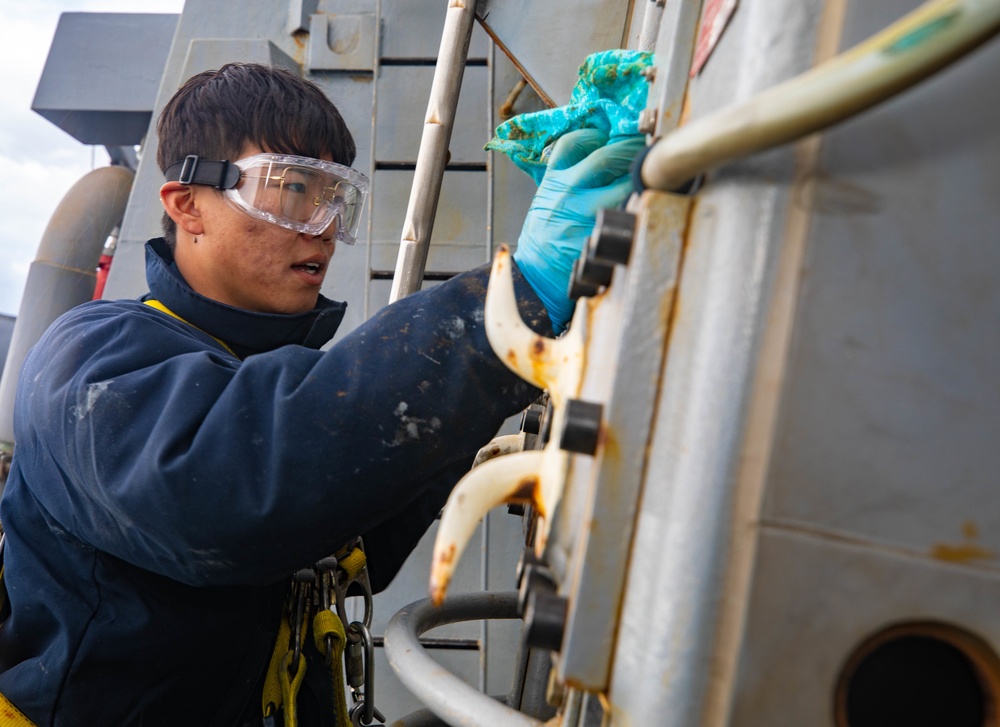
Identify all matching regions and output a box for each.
[766,2,1000,568]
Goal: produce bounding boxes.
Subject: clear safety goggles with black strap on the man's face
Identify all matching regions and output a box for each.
[166,154,369,245]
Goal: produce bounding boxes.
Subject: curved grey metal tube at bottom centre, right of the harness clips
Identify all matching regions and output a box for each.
[385,591,544,727]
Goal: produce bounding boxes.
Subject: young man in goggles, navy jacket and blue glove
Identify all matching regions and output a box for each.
[0,64,639,727]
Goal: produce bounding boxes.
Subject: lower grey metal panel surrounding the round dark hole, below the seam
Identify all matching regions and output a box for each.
[729,529,1000,727]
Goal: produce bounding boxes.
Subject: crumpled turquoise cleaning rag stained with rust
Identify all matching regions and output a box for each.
[486,50,653,184]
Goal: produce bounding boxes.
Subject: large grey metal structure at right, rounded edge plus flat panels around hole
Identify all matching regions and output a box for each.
[609,0,1000,726]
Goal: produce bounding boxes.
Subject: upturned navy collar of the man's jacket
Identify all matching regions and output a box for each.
[144,237,347,358]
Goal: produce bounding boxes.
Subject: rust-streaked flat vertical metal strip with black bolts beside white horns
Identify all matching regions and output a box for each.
[558,192,690,691]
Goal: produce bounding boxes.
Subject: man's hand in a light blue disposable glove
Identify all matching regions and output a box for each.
[514,129,645,333]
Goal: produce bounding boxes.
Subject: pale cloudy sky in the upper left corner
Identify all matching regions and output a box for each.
[0,0,184,315]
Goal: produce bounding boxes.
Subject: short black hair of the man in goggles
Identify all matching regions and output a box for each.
[156,63,357,247]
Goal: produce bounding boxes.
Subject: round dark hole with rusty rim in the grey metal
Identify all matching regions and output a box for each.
[835,622,1000,727]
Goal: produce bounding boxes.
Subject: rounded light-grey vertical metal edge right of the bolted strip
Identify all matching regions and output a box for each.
[608,2,818,727]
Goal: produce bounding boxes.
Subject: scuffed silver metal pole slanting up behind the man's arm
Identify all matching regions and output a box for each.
[389,0,476,303]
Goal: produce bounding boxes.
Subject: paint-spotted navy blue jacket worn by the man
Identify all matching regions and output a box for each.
[0,240,549,727]
